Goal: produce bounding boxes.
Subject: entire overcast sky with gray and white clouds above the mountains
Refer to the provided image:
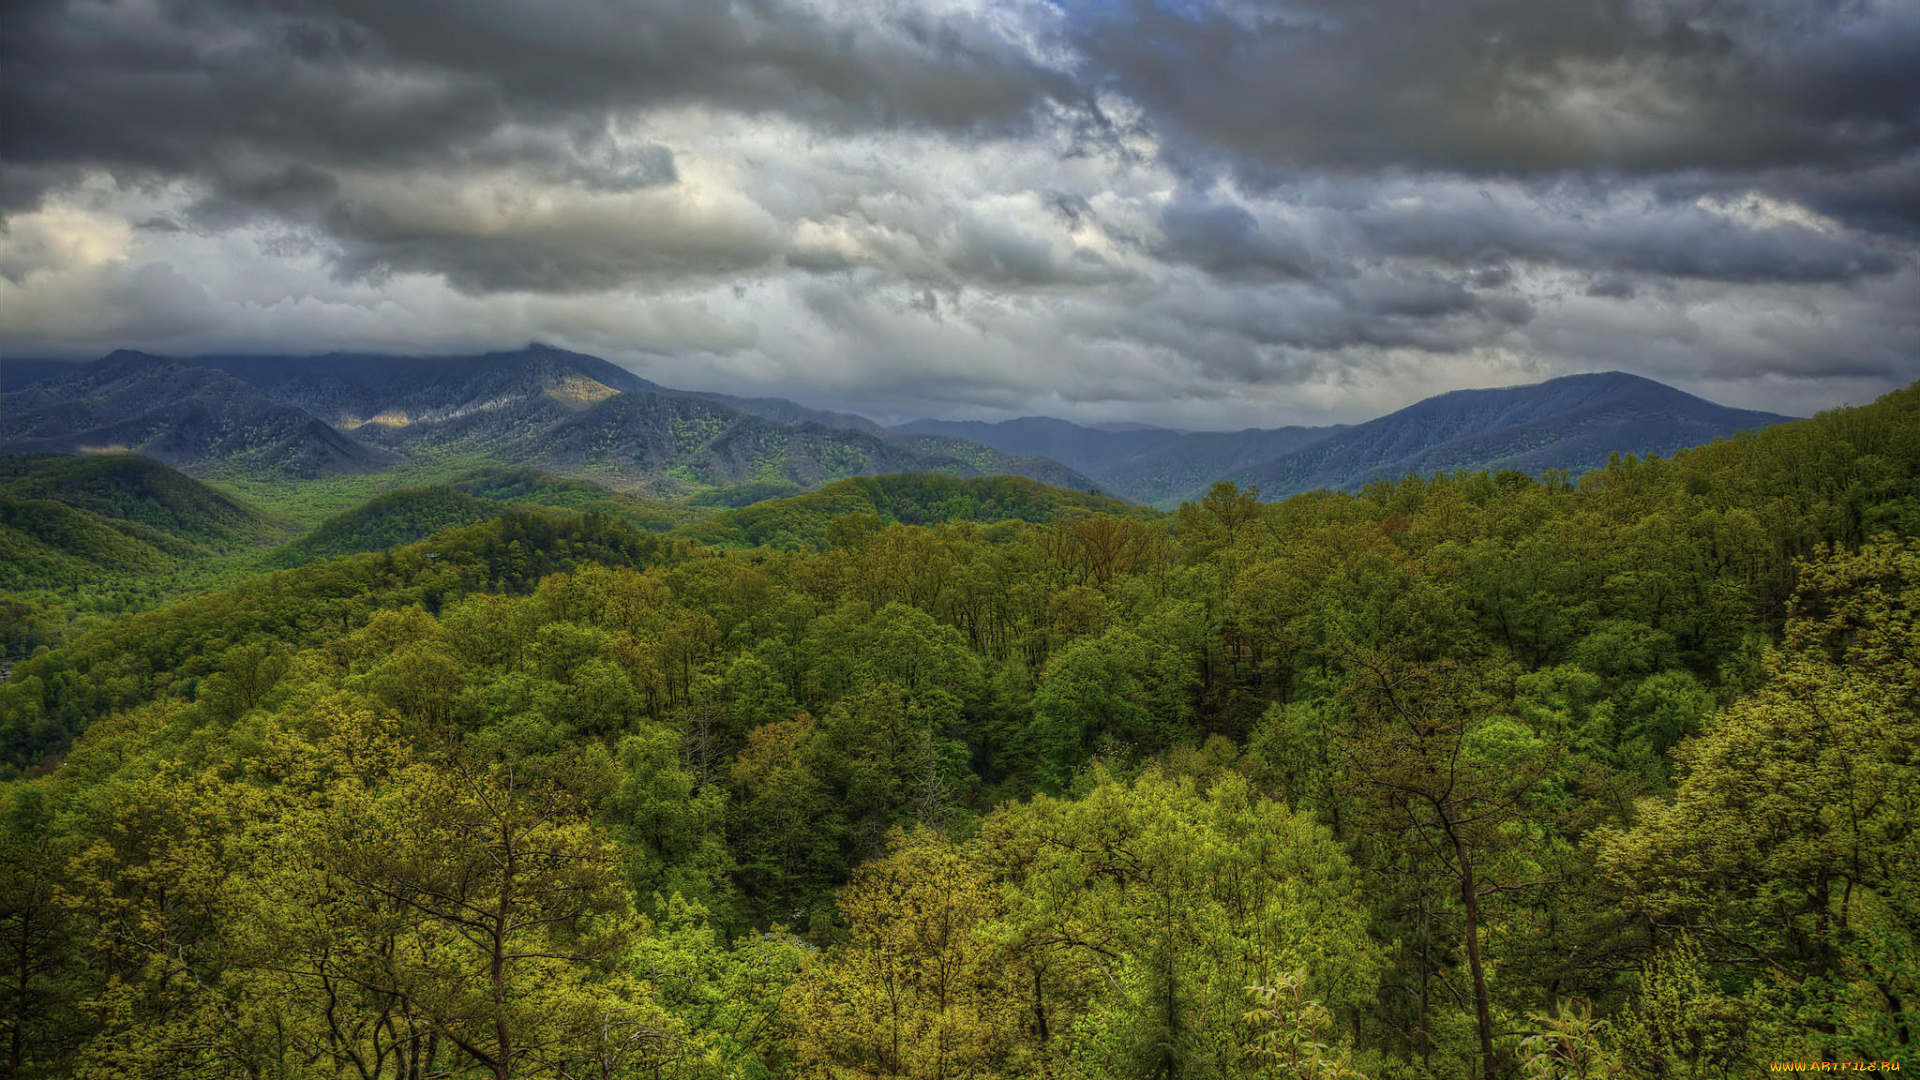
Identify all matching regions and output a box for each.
[0,0,1920,429]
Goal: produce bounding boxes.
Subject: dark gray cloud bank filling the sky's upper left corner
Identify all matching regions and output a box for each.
[0,0,1068,206]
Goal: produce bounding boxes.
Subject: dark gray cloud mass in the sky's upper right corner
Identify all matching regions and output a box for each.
[1073,0,1920,173]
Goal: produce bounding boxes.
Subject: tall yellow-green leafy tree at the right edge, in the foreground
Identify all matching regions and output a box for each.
[1601,540,1920,1061]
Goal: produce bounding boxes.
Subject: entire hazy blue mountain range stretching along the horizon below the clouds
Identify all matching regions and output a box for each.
[0,346,1789,507]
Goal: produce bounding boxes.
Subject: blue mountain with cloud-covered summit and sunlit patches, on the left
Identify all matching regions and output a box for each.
[0,346,1092,498]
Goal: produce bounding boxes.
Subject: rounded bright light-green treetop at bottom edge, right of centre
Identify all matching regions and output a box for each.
[981,769,1379,1076]
